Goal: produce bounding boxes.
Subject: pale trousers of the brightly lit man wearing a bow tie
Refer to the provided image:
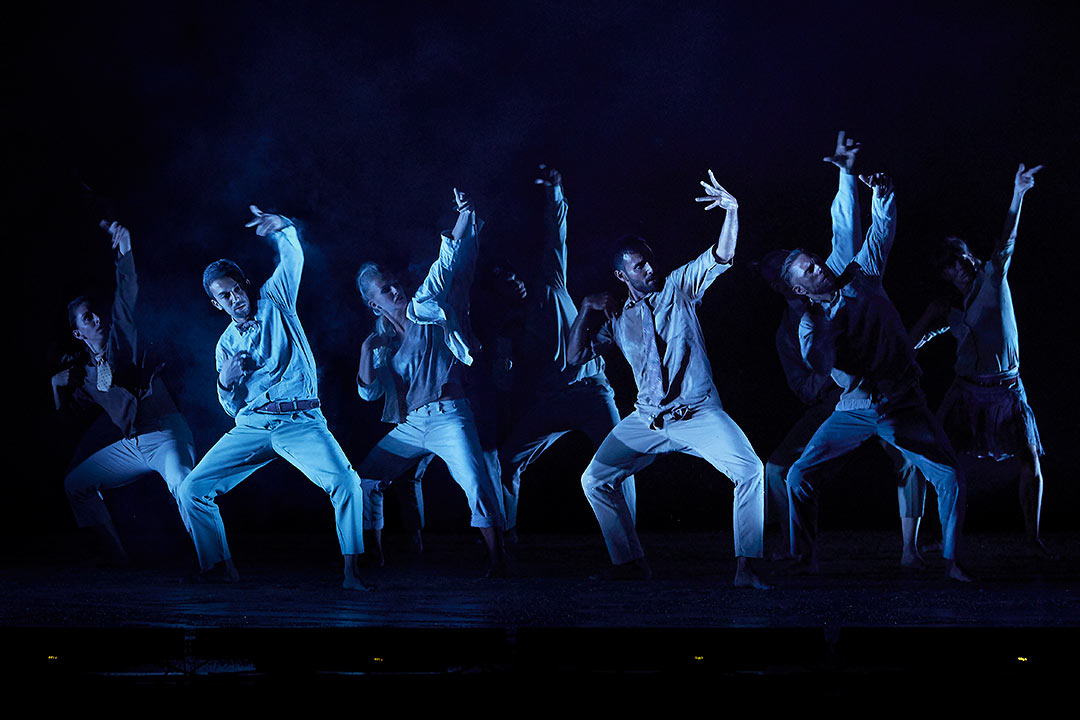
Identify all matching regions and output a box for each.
[179,410,364,570]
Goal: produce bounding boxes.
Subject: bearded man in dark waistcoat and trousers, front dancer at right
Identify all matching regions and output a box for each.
[781,173,971,582]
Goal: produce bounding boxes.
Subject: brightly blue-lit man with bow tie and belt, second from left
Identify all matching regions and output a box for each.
[180,205,369,589]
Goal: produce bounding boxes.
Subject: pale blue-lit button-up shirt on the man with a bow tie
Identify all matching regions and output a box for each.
[216,225,319,423]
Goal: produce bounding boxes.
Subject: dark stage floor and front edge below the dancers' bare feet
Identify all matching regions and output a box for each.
[0,532,1080,681]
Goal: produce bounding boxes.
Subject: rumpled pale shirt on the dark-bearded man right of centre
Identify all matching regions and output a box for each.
[593,246,731,417]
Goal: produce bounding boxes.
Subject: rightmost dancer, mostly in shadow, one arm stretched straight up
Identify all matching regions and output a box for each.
[912,163,1047,554]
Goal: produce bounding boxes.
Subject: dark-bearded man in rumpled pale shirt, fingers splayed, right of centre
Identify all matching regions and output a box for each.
[567,171,768,589]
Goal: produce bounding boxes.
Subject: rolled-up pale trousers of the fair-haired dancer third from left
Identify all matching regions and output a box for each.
[357,398,503,530]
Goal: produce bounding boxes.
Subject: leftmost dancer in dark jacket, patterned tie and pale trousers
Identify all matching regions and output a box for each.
[52,220,194,565]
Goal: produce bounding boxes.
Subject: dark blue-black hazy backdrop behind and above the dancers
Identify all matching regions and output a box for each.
[5,0,1080,543]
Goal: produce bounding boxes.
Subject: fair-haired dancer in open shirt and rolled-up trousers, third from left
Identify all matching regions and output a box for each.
[356,189,505,576]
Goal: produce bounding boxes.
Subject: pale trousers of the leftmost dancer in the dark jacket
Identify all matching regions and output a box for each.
[64,413,194,532]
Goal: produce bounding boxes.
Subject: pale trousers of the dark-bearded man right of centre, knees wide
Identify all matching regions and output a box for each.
[581,404,765,565]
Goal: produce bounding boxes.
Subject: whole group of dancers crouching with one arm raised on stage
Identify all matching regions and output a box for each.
[52,132,1042,589]
